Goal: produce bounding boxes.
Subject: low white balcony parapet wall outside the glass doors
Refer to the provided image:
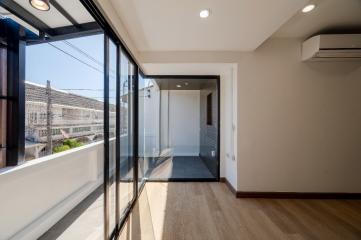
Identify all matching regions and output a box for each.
[0,142,104,240]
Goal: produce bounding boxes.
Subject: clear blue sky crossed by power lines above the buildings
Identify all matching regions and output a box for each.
[25,34,116,101]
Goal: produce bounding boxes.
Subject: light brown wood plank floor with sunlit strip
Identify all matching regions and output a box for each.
[119,183,361,240]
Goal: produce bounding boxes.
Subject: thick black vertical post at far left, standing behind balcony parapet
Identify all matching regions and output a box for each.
[0,20,26,166]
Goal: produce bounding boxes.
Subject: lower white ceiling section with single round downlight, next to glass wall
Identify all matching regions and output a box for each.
[111,0,306,51]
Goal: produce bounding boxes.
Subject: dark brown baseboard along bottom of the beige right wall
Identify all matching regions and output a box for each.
[220,178,361,199]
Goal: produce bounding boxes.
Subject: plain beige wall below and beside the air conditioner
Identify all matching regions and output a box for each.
[238,39,361,192]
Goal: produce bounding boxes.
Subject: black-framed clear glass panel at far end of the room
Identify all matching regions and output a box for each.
[138,76,219,181]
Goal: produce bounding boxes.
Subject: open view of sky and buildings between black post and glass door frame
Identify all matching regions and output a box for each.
[25,35,104,160]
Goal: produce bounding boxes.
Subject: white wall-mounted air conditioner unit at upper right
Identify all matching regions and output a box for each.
[302,34,361,61]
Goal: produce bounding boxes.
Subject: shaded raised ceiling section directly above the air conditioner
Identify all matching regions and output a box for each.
[273,0,361,38]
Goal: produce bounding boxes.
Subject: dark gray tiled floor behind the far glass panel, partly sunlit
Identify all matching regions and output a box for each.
[148,156,215,180]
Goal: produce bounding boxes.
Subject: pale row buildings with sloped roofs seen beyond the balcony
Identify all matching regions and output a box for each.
[25,82,118,160]
